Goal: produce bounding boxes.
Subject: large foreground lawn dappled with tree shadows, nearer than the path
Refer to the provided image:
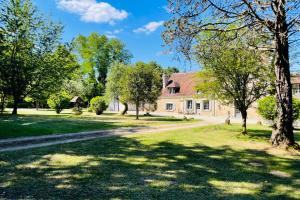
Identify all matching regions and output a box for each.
[0,125,300,200]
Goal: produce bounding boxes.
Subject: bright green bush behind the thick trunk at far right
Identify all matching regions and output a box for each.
[258,96,300,121]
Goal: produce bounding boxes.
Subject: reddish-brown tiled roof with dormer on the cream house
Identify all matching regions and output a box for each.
[161,72,196,97]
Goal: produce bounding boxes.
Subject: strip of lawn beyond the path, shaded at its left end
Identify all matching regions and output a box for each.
[0,109,196,139]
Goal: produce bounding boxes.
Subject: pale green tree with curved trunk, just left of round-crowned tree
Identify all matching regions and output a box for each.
[105,63,128,115]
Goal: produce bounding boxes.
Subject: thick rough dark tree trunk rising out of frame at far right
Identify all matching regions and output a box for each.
[270,0,295,146]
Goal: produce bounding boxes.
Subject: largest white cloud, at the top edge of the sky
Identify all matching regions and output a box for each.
[56,0,128,24]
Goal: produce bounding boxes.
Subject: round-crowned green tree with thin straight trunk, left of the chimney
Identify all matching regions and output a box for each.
[124,62,161,120]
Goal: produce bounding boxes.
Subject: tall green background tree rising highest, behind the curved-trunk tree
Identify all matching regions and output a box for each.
[74,33,132,97]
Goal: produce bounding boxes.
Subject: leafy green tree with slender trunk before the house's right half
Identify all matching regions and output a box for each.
[196,34,272,134]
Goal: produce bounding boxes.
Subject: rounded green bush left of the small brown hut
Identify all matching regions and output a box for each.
[47,92,70,114]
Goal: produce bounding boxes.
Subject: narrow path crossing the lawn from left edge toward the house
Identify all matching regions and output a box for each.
[0,121,219,152]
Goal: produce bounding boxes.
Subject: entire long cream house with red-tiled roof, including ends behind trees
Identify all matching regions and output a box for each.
[107,72,300,119]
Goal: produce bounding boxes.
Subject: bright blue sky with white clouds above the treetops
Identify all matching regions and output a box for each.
[33,0,198,71]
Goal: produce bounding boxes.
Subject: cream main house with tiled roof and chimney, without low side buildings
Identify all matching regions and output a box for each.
[157,73,260,118]
